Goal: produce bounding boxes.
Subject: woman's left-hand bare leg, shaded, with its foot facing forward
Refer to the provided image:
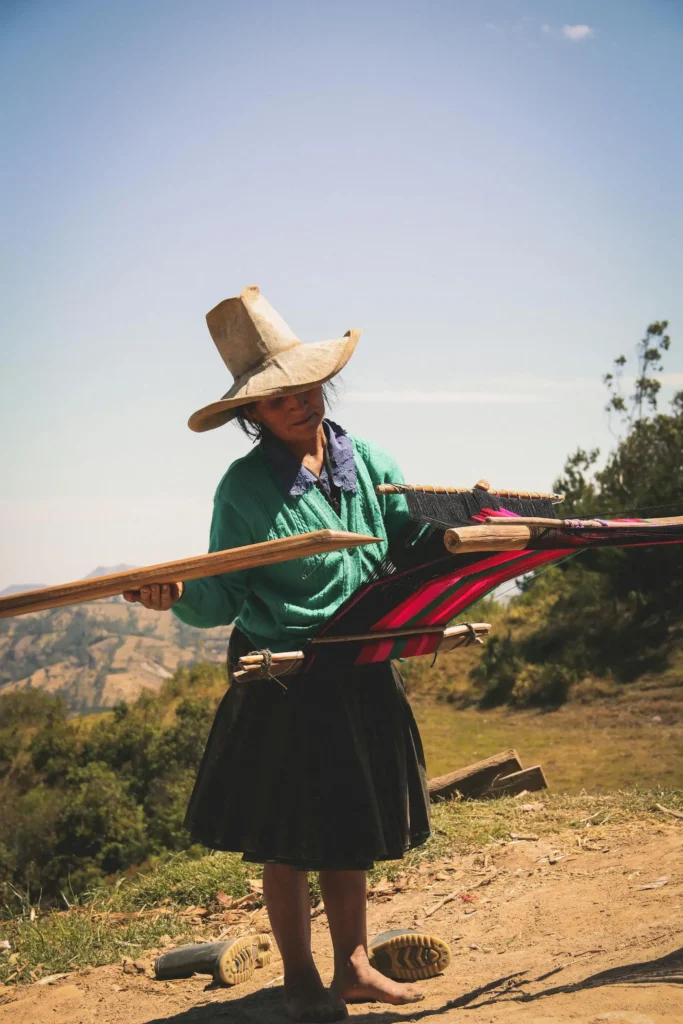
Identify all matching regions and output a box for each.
[263,864,346,1022]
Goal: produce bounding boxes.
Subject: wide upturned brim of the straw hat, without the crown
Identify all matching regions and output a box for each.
[187,330,360,433]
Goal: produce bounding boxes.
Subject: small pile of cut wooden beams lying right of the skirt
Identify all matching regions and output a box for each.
[429,751,548,803]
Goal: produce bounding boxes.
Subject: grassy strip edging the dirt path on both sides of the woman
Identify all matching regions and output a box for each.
[0,788,683,984]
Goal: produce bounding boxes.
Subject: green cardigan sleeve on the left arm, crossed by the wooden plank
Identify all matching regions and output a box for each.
[171,495,253,629]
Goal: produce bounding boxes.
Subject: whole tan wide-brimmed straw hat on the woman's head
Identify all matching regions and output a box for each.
[187,285,360,431]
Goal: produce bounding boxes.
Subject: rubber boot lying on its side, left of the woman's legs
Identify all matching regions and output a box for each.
[155,935,271,985]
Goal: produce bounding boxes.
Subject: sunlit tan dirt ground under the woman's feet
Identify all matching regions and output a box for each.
[0,815,683,1024]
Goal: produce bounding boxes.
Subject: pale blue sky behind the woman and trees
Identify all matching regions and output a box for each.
[0,0,683,588]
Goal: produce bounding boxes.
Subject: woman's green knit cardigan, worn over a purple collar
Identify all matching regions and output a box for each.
[173,435,409,651]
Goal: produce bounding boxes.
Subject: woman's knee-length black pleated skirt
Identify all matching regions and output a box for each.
[185,630,429,871]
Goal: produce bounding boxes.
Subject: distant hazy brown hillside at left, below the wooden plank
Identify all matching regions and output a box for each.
[0,598,230,714]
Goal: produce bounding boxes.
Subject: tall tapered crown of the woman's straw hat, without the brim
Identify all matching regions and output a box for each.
[206,285,301,380]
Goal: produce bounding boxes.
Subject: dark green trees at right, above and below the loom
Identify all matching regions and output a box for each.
[473,321,683,703]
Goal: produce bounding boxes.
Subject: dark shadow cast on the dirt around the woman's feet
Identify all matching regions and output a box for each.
[143,947,683,1024]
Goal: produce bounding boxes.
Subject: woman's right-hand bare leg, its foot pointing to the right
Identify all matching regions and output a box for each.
[321,871,423,1006]
